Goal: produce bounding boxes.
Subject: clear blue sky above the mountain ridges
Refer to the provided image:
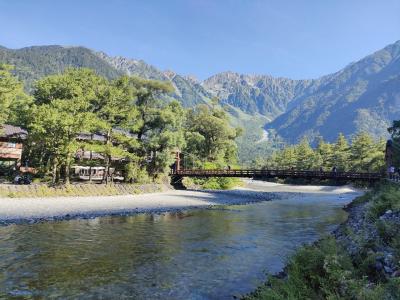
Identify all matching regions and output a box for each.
[0,0,400,79]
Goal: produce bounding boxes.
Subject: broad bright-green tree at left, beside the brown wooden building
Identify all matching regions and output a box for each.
[29,69,107,183]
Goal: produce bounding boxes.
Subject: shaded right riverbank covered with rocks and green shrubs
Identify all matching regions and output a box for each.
[245,184,400,299]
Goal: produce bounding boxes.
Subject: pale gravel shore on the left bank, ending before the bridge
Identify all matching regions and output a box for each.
[0,189,285,226]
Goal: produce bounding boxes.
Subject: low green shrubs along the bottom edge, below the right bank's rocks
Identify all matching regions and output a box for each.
[245,237,400,300]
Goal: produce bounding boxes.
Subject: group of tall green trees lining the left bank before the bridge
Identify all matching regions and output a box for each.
[0,65,241,184]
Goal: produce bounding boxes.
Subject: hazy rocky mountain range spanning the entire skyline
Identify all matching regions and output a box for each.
[0,41,400,158]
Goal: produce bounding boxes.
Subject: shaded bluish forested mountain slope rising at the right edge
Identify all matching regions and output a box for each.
[267,41,400,142]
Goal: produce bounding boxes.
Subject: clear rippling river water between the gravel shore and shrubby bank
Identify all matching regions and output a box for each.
[0,194,354,299]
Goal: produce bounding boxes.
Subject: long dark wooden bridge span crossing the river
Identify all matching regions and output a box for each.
[170,169,385,181]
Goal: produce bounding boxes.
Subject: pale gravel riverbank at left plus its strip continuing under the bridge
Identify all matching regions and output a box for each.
[0,181,359,224]
